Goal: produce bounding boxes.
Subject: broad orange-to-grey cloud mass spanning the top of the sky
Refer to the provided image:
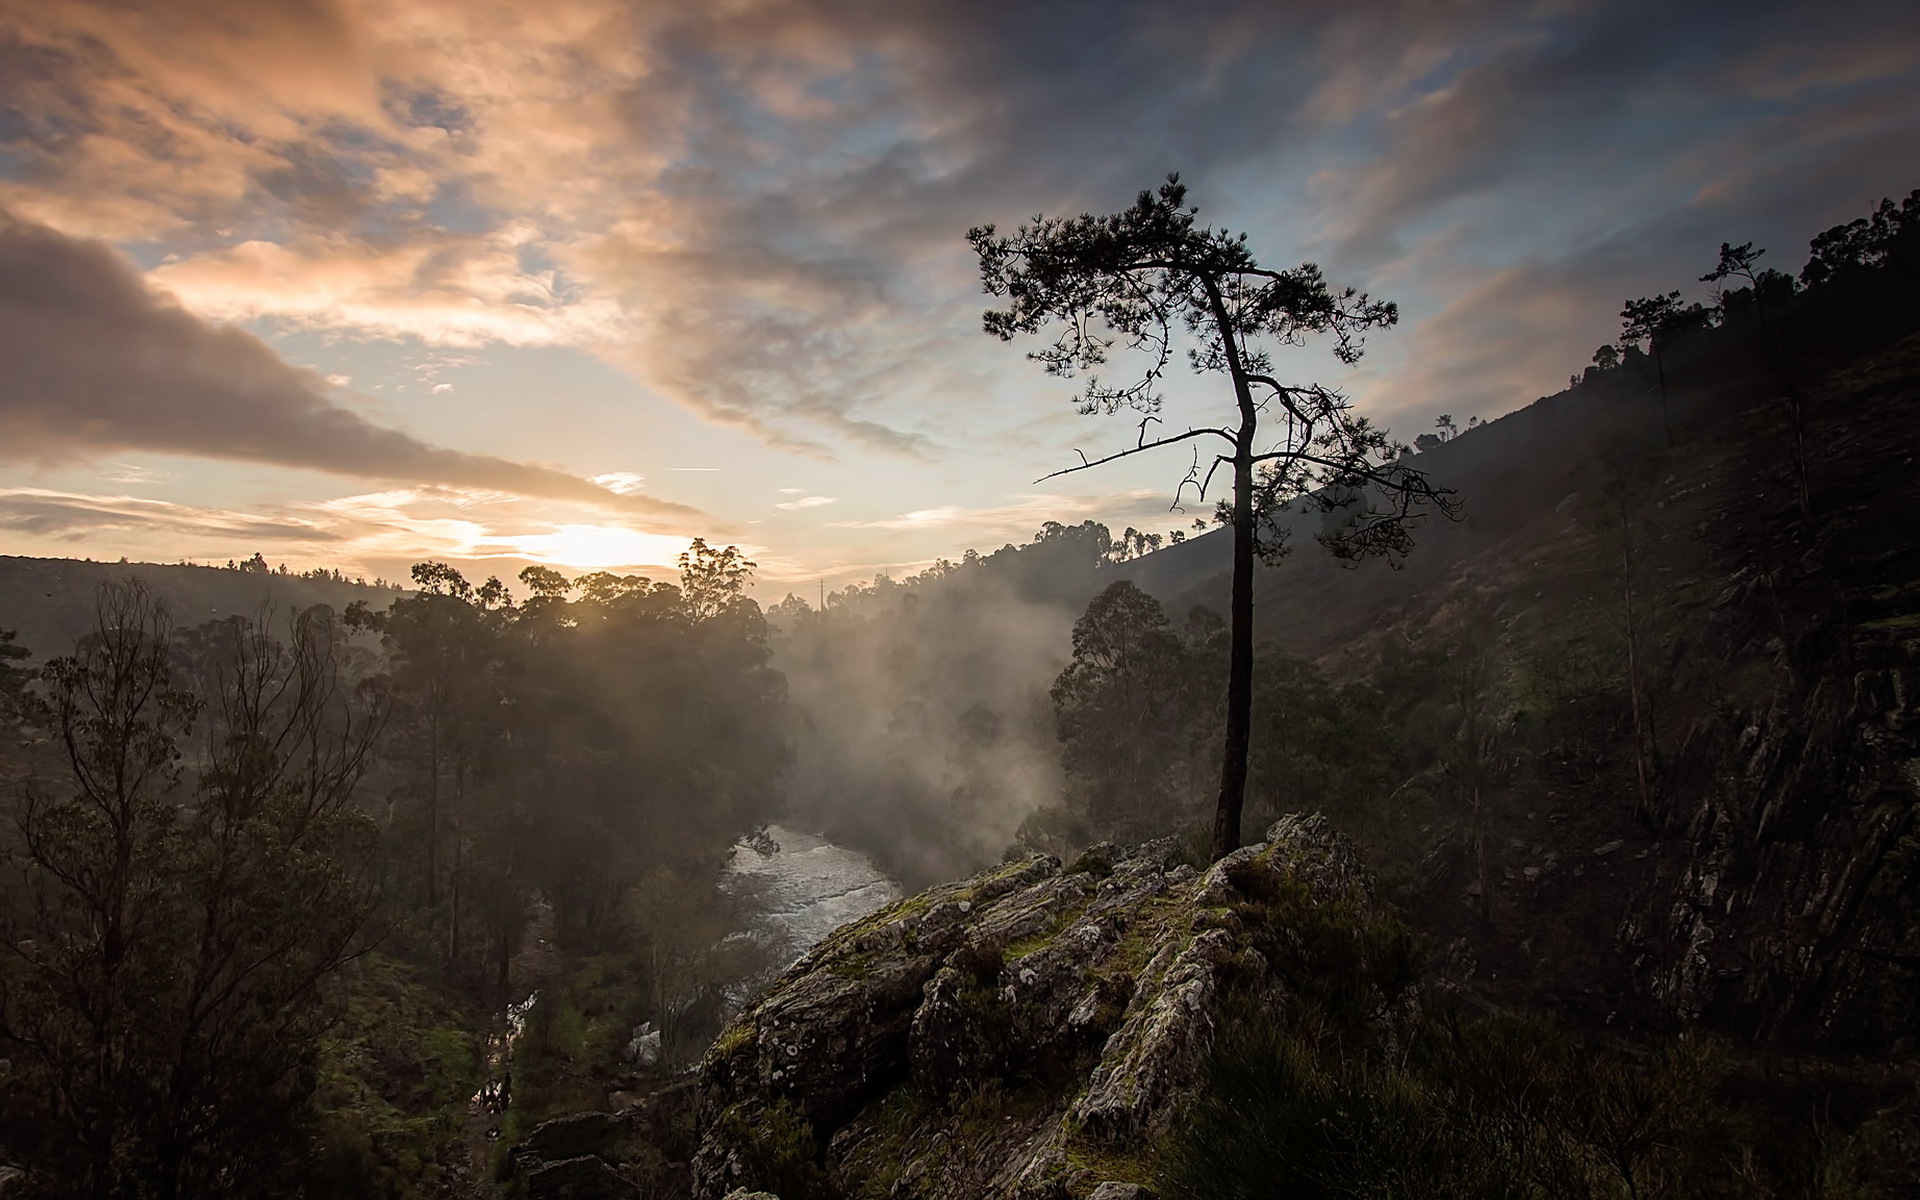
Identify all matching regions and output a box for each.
[0,0,1920,457]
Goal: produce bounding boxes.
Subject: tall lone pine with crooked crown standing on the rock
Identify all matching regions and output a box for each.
[968,175,1448,858]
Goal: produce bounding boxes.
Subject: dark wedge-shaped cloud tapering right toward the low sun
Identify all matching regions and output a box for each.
[0,215,710,528]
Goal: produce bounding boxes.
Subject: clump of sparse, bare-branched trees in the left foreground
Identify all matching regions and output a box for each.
[0,584,378,1198]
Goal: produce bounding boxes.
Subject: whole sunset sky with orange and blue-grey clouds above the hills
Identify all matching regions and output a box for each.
[0,0,1920,599]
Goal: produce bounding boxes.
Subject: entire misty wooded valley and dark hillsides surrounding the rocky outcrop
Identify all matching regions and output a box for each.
[0,190,1920,1200]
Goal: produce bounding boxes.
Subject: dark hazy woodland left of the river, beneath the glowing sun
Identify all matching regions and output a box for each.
[0,541,789,1196]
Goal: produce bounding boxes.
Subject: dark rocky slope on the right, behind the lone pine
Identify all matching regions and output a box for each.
[1137,336,1920,1052]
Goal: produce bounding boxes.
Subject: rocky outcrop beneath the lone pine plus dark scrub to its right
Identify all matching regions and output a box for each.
[511,816,1920,1200]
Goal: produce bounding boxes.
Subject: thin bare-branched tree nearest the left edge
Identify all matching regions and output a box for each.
[0,584,198,1196]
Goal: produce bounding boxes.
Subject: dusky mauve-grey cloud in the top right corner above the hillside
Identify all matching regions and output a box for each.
[1315,0,1920,267]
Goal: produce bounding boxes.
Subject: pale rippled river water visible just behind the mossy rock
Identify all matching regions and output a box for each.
[728,826,900,970]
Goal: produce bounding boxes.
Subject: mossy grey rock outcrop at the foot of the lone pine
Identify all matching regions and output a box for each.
[693,816,1390,1200]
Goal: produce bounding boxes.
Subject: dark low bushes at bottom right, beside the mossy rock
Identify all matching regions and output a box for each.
[1156,996,1880,1200]
